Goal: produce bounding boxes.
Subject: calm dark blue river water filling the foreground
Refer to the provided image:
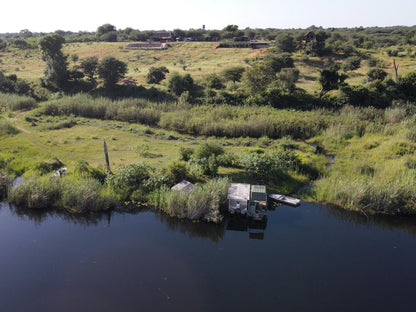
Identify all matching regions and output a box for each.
[0,203,416,312]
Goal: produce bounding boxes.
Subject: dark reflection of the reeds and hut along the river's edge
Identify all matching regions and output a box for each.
[1,202,416,243]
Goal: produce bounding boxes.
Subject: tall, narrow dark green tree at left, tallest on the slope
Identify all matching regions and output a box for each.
[39,34,68,90]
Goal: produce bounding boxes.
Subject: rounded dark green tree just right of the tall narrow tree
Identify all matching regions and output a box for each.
[98,56,127,88]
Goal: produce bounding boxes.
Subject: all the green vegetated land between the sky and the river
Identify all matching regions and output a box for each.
[0,27,416,222]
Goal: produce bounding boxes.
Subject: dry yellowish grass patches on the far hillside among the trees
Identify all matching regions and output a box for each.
[0,42,416,94]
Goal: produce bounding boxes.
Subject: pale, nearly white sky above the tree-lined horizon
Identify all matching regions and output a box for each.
[0,0,416,33]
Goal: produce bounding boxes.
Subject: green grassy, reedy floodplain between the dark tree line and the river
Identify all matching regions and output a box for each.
[0,96,416,214]
